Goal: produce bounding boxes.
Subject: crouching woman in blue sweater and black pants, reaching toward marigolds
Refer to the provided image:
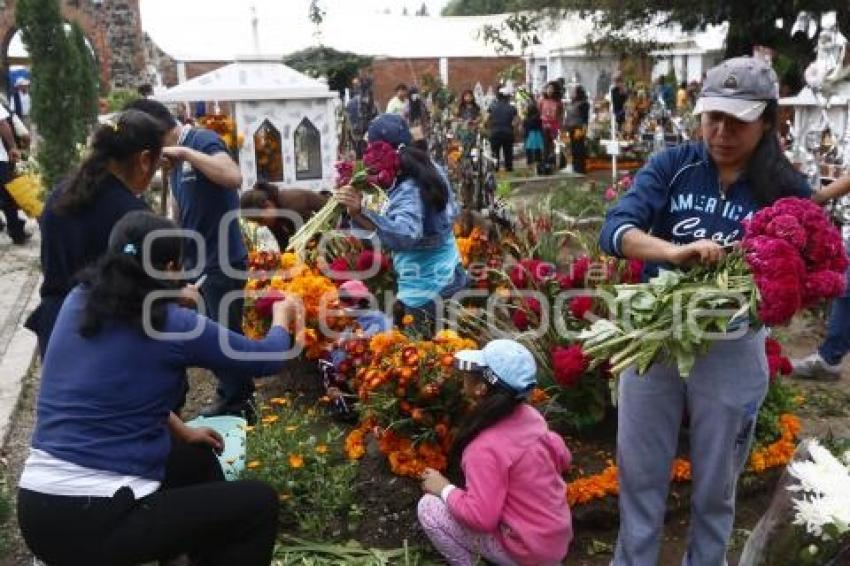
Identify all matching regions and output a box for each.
[18,211,297,566]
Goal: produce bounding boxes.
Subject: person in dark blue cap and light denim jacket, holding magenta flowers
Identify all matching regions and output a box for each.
[336,114,468,338]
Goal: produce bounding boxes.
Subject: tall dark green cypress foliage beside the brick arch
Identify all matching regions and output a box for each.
[15,0,98,191]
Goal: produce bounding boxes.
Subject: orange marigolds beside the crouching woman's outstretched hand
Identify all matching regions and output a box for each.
[242,252,348,360]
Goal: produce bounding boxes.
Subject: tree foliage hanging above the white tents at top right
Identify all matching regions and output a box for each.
[444,0,850,64]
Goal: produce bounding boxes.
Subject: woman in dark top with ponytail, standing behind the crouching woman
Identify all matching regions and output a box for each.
[26,111,166,359]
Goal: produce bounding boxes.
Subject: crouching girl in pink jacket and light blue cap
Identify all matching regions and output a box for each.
[418,340,572,566]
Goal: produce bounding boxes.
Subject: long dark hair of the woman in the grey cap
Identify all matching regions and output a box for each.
[746,100,805,206]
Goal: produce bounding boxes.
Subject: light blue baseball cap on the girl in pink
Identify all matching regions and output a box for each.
[455,339,537,397]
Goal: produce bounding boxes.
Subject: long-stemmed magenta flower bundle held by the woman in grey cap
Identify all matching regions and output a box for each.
[580,198,847,377]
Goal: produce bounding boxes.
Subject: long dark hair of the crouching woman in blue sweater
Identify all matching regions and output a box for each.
[80,210,185,338]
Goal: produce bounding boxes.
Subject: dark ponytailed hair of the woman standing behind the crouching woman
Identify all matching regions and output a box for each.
[54,110,166,214]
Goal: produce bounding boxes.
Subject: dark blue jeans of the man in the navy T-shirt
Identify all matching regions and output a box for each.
[201,271,254,406]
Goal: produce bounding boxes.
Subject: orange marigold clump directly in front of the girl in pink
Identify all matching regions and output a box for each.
[341,330,477,477]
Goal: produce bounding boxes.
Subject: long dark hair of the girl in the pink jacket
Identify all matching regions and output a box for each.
[446,378,525,487]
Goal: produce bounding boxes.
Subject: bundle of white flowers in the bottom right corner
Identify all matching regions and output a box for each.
[741,440,850,566]
